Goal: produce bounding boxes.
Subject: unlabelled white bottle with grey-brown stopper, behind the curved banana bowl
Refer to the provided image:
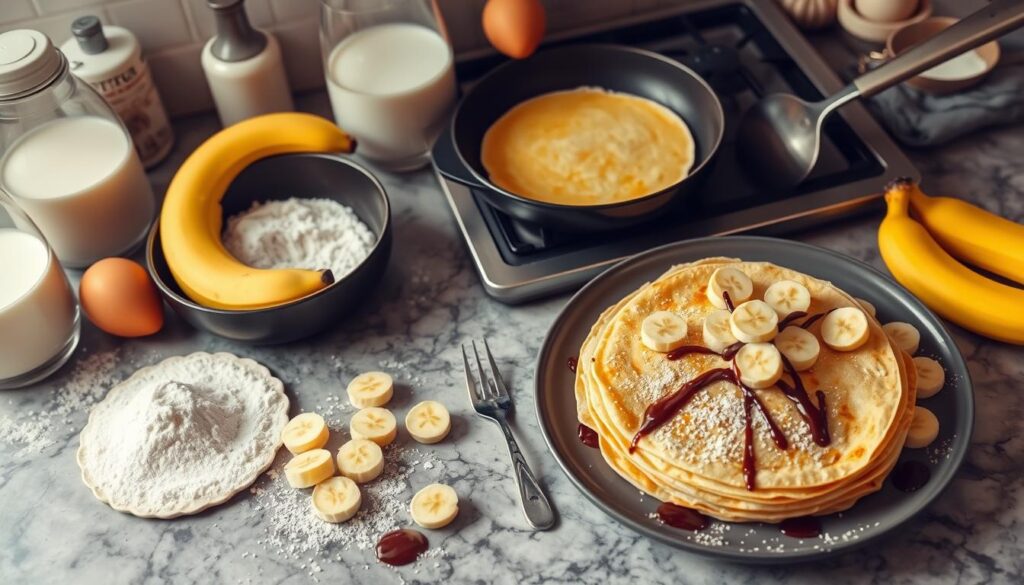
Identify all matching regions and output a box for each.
[202,0,295,127]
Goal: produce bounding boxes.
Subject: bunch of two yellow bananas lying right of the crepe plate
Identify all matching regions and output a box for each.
[879,179,1024,344]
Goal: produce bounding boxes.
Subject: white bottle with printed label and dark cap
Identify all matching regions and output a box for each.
[60,16,174,168]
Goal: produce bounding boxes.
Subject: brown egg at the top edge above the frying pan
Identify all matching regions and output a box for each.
[483,0,547,58]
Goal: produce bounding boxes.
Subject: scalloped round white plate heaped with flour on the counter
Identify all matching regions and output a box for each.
[78,352,289,518]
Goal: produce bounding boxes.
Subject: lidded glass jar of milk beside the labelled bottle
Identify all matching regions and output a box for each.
[0,30,156,267]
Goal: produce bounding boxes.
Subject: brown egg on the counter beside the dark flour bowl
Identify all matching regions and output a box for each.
[78,258,164,337]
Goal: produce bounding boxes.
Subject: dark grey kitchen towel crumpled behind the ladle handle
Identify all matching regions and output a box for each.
[867,52,1024,147]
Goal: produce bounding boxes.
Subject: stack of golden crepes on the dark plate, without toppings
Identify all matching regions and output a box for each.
[575,258,915,523]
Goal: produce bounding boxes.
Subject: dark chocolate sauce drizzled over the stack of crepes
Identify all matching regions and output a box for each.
[622,291,831,492]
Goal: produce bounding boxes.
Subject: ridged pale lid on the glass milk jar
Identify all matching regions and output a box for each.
[0,29,63,99]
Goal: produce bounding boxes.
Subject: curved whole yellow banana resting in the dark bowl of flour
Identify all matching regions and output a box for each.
[160,113,355,310]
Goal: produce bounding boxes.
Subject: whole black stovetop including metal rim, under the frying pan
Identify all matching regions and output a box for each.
[437,0,918,303]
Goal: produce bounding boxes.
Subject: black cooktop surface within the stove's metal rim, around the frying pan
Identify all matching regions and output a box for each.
[457,4,885,264]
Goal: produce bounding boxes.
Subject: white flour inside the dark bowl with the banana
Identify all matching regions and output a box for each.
[223,198,376,280]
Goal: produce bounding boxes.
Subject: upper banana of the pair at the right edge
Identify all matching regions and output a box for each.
[910,184,1024,284]
